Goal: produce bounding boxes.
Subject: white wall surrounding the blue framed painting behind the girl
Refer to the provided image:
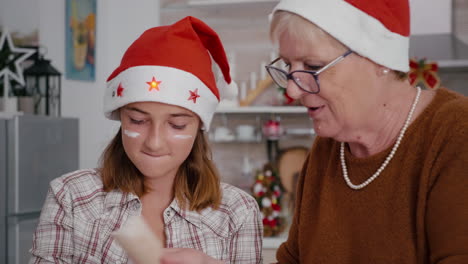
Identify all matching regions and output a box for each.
[39,0,159,168]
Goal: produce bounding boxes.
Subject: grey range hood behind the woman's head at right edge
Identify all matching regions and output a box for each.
[409,34,468,68]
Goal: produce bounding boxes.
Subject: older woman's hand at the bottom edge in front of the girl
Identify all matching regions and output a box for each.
[160,248,223,264]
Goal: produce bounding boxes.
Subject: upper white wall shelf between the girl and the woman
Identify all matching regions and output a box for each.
[216,106,307,114]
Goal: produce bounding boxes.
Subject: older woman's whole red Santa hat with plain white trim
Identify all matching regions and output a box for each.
[273,0,410,72]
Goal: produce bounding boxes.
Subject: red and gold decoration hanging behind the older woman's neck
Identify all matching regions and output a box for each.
[409,58,440,90]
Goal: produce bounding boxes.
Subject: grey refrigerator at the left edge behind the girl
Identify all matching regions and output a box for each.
[0,114,79,264]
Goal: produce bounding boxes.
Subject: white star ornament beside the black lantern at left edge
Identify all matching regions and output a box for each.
[0,31,36,85]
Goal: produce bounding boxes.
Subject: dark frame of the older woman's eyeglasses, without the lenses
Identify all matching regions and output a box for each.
[265,50,353,94]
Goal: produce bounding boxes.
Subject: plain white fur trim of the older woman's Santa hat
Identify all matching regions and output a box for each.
[273,0,409,72]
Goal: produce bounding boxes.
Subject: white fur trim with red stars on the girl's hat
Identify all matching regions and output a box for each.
[104,66,219,130]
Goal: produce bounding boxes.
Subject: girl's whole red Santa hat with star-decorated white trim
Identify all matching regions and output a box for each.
[104,17,237,130]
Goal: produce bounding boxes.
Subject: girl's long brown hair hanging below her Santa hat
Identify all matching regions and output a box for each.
[100,129,221,211]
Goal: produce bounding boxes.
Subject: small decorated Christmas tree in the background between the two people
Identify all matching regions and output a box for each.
[252,163,285,237]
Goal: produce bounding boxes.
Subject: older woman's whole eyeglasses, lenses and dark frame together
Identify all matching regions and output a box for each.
[265,50,353,94]
